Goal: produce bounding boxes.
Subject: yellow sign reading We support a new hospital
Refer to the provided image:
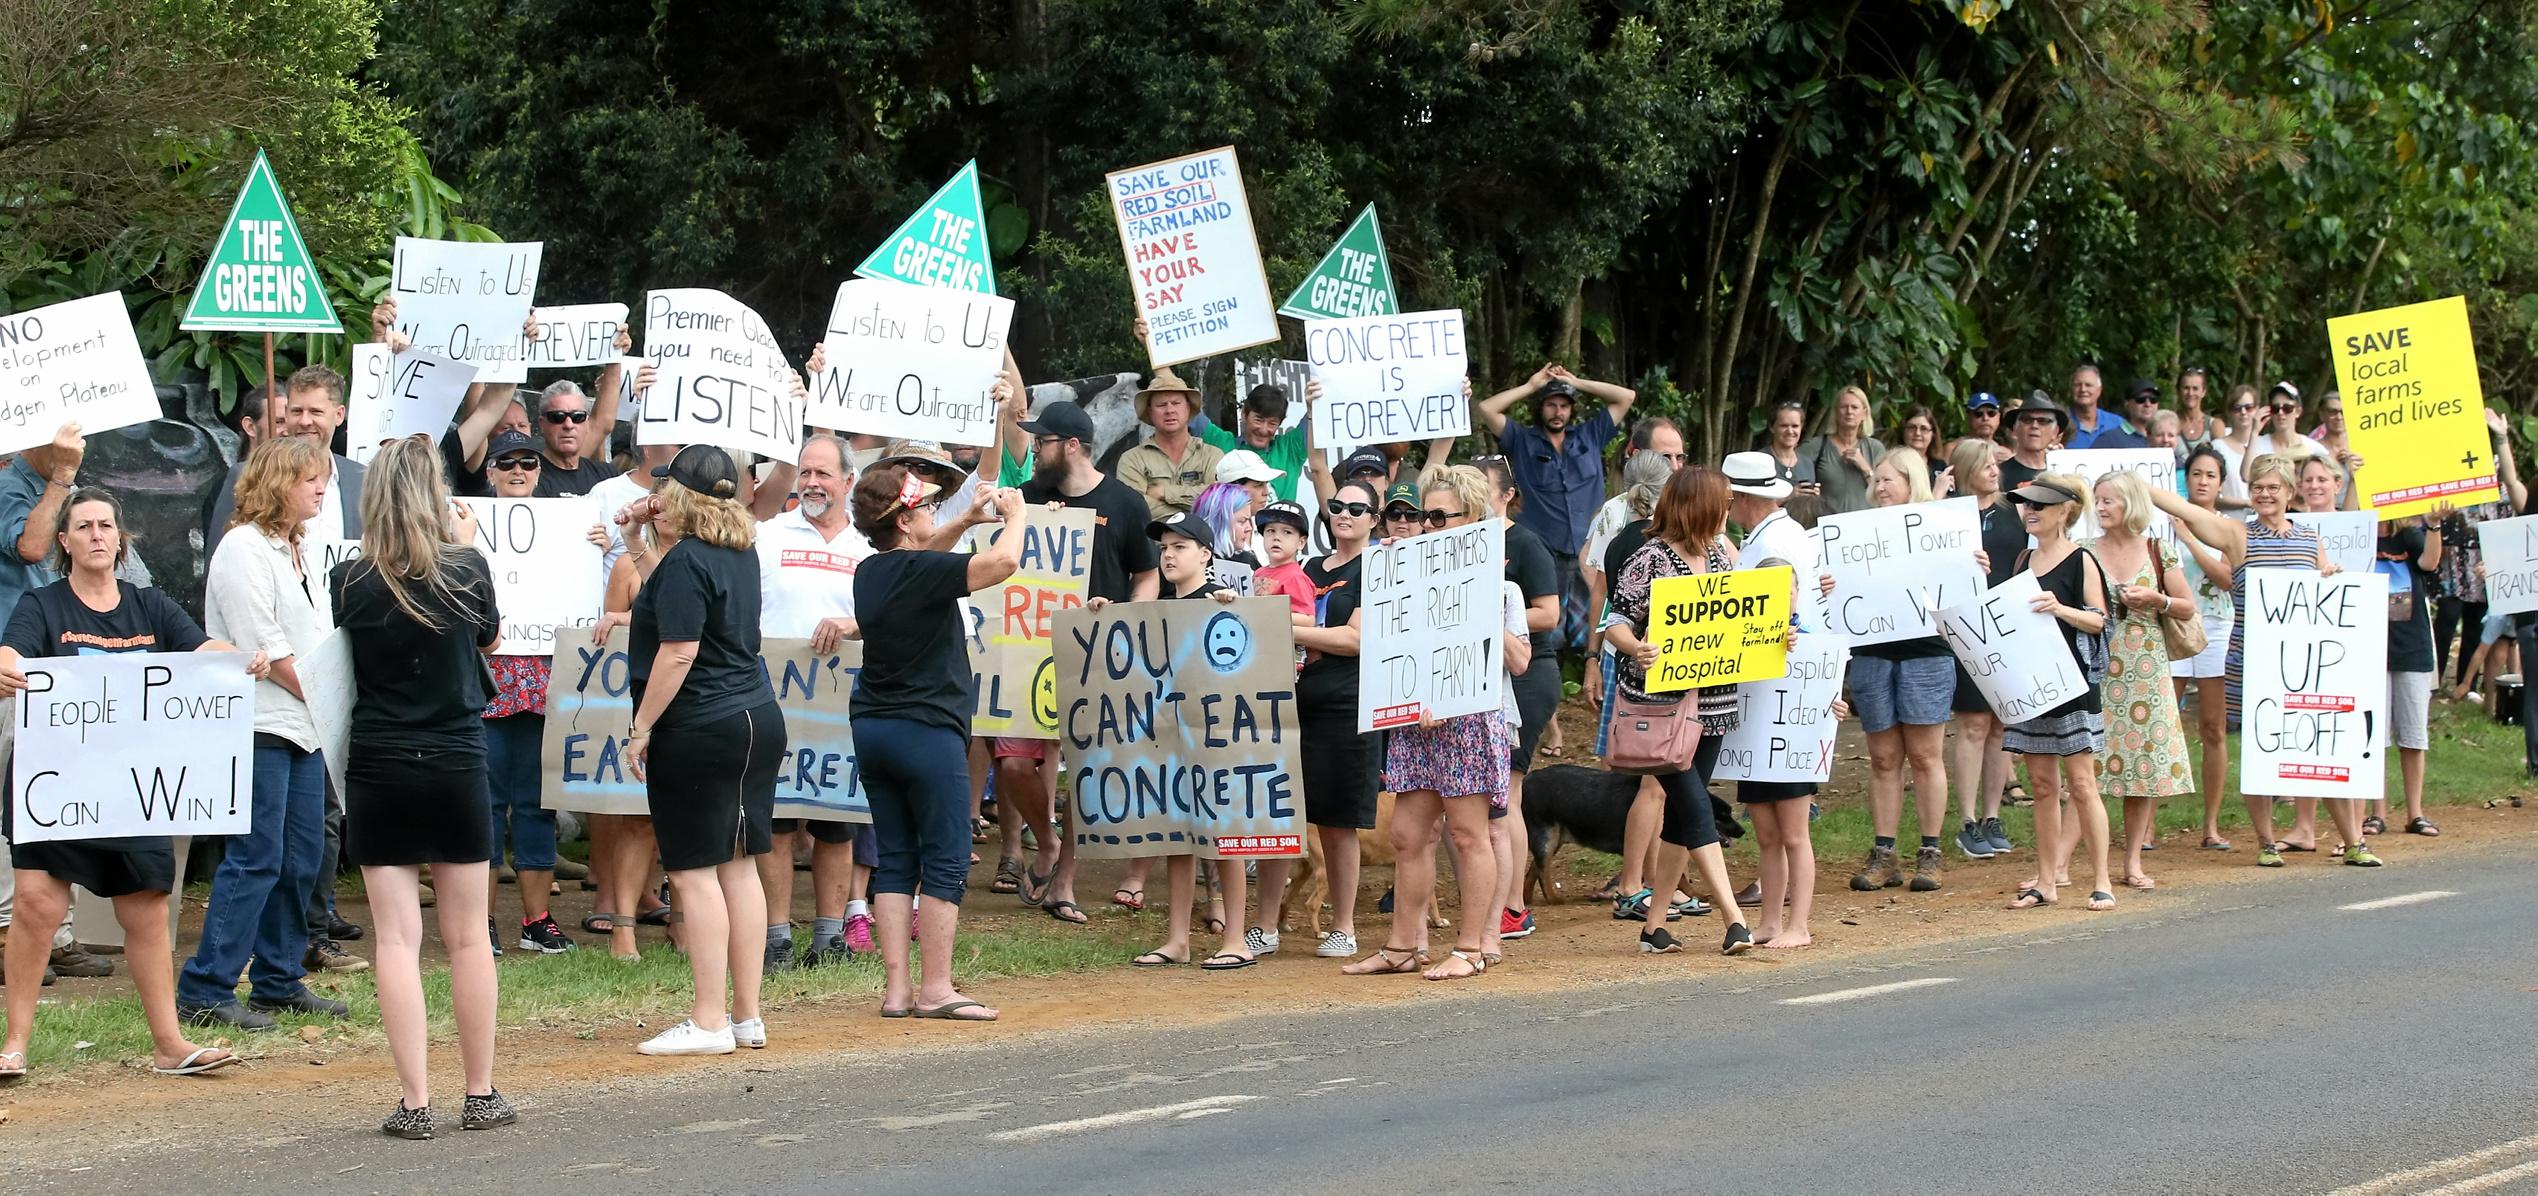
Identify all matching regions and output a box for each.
[1647,566,1792,693]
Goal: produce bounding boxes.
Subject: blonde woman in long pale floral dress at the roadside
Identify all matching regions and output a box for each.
[2063,470,2200,889]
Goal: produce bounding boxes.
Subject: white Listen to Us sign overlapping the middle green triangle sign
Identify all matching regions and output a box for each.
[807,279,1013,444]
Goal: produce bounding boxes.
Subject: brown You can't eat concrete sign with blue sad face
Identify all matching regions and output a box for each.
[1056,599,1305,858]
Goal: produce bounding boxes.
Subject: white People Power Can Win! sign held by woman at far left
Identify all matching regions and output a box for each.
[10,653,256,843]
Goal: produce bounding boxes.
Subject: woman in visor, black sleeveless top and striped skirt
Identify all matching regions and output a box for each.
[2000,472,2114,909]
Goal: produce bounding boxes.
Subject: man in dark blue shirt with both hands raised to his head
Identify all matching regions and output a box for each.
[1480,363,1640,648]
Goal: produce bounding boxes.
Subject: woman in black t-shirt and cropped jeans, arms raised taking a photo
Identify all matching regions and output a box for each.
[848,465,1020,1021]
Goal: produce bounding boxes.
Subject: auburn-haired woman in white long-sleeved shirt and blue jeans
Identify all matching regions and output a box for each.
[175,437,350,1031]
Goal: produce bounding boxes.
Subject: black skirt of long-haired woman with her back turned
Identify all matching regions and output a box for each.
[347,747,492,868]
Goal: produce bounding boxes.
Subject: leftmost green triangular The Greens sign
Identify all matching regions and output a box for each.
[178,150,343,333]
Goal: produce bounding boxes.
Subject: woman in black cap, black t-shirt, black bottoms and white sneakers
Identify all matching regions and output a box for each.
[627,444,784,1054]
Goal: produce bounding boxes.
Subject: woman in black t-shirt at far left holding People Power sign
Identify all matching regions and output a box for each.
[0,488,266,1079]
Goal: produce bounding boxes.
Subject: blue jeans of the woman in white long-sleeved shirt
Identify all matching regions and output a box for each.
[175,744,325,1008]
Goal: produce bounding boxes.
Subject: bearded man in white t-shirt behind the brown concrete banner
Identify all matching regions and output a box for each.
[756,434,873,970]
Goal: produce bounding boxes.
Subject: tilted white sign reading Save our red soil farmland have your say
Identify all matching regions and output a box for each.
[1101,145,1279,366]
